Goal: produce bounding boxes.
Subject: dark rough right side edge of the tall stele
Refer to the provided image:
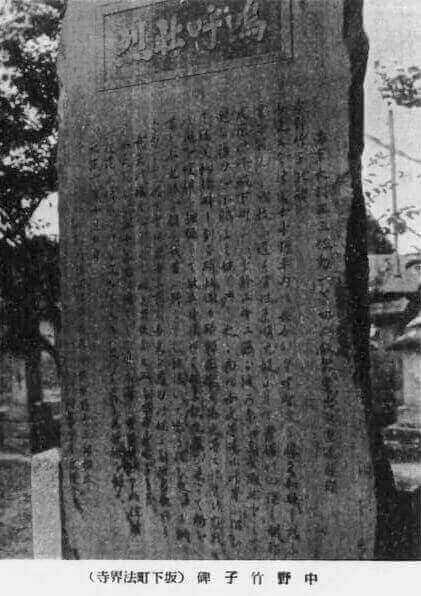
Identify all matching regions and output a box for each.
[343,0,398,560]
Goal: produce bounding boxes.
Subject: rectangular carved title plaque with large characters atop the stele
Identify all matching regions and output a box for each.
[102,0,293,89]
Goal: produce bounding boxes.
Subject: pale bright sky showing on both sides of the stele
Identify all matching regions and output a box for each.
[34,0,421,254]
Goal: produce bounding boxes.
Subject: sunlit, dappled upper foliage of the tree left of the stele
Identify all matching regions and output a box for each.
[0,0,64,244]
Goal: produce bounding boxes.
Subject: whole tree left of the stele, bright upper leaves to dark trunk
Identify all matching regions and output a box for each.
[0,0,65,420]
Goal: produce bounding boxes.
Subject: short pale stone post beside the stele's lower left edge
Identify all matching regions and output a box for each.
[31,449,62,559]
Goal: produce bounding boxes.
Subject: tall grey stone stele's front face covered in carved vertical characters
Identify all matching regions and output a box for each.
[59,0,376,559]
